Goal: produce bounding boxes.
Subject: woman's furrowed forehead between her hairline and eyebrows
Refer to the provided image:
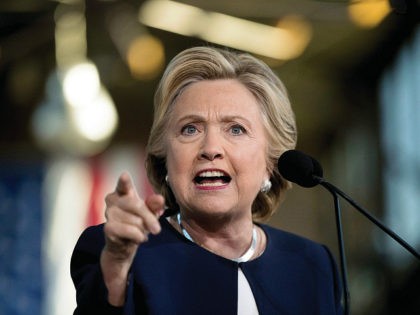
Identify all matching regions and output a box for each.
[173,79,261,118]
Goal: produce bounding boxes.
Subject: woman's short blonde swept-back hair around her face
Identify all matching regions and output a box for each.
[146,47,297,221]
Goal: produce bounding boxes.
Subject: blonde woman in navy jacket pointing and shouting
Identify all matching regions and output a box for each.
[71,47,341,315]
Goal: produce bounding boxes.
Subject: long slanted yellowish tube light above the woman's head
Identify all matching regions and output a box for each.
[139,0,311,60]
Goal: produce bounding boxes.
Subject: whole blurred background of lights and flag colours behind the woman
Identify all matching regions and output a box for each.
[0,0,420,315]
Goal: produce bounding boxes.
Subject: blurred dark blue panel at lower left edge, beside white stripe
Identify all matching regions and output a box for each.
[0,160,43,315]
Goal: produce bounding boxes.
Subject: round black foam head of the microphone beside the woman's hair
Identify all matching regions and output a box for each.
[278,150,323,188]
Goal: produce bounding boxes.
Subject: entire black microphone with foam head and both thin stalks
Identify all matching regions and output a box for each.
[278,150,420,315]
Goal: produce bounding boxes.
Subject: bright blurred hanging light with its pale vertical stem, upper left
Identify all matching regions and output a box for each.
[46,0,118,156]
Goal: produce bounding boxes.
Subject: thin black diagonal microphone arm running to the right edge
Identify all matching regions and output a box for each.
[313,175,420,260]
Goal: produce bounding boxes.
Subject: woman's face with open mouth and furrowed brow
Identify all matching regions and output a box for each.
[167,80,269,220]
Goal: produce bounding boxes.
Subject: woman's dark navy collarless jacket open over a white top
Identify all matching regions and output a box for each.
[71,218,342,315]
